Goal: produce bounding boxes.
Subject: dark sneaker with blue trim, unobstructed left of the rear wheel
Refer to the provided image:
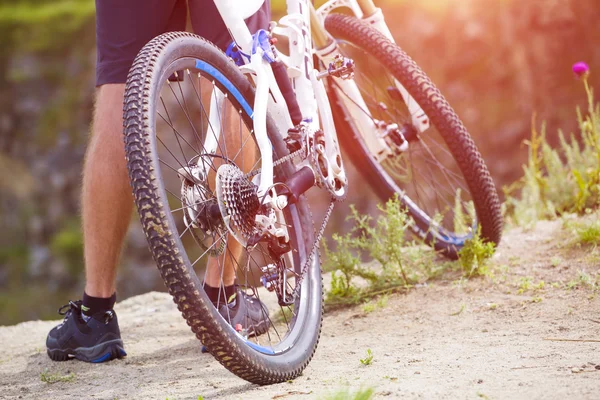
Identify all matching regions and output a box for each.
[46,301,127,363]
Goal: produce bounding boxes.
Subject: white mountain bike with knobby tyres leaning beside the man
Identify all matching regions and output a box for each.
[124,0,502,384]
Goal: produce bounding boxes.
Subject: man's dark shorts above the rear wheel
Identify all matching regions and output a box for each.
[96,0,271,86]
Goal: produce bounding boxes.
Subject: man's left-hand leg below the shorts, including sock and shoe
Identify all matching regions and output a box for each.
[46,84,132,362]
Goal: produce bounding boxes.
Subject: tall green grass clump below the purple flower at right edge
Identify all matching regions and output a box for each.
[504,77,600,226]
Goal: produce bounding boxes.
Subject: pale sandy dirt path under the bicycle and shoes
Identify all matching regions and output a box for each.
[0,222,600,399]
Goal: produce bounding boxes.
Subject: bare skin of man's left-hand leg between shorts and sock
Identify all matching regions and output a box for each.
[81,84,133,297]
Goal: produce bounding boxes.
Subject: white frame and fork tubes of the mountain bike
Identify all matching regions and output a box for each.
[209,0,429,196]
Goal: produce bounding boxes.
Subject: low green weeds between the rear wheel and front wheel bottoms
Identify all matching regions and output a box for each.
[324,196,456,306]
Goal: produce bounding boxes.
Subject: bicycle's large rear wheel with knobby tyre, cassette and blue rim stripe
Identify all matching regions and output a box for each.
[124,32,322,384]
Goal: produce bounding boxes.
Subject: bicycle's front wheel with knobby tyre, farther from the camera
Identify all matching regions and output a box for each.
[325,14,502,258]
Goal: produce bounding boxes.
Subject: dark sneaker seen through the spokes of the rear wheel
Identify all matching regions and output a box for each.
[219,287,269,336]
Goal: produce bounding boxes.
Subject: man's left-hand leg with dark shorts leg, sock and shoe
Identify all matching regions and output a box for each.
[46,0,187,362]
